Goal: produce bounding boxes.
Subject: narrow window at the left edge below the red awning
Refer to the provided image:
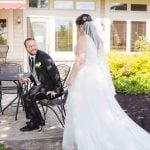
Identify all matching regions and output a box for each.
[0,19,8,45]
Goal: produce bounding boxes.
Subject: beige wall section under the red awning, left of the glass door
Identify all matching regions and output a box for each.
[0,9,24,62]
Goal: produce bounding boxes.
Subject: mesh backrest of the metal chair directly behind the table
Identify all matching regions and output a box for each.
[0,63,22,73]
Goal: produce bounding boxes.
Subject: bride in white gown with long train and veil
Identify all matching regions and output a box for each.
[62,14,150,150]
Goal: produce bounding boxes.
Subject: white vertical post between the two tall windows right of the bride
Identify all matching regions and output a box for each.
[126,20,131,53]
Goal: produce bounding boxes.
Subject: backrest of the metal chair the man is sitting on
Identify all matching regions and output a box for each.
[57,64,70,86]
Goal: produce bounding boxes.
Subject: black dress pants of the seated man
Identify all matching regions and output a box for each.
[23,84,46,125]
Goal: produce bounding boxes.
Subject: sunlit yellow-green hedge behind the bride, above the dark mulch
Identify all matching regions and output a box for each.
[108,52,150,94]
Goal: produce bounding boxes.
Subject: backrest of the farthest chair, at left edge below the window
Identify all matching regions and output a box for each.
[0,45,9,62]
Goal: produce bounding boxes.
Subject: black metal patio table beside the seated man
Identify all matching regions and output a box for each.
[0,73,22,120]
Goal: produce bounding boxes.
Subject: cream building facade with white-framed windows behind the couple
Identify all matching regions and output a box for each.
[0,0,150,68]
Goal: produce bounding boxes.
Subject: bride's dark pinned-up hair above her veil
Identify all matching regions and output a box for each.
[76,14,93,25]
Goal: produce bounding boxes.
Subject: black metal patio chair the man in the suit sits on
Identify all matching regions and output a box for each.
[35,64,70,127]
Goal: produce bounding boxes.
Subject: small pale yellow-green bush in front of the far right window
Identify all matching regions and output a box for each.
[134,36,150,52]
